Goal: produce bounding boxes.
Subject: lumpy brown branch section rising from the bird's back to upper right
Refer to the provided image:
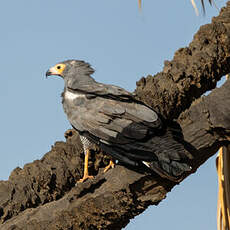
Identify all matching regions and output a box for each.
[136,2,230,119]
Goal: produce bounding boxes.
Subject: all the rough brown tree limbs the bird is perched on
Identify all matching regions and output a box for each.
[0,3,230,230]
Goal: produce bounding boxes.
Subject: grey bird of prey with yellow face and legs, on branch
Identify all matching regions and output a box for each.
[46,59,191,182]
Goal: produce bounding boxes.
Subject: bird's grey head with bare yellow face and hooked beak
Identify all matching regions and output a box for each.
[46,60,94,82]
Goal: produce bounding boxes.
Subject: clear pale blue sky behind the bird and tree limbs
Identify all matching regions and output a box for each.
[0,0,226,230]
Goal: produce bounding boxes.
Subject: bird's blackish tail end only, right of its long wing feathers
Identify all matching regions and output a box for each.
[142,123,193,181]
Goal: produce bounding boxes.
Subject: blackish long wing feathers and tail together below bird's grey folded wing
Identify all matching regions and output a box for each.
[101,120,192,182]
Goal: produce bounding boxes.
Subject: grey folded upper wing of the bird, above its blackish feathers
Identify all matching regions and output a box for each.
[69,97,161,144]
